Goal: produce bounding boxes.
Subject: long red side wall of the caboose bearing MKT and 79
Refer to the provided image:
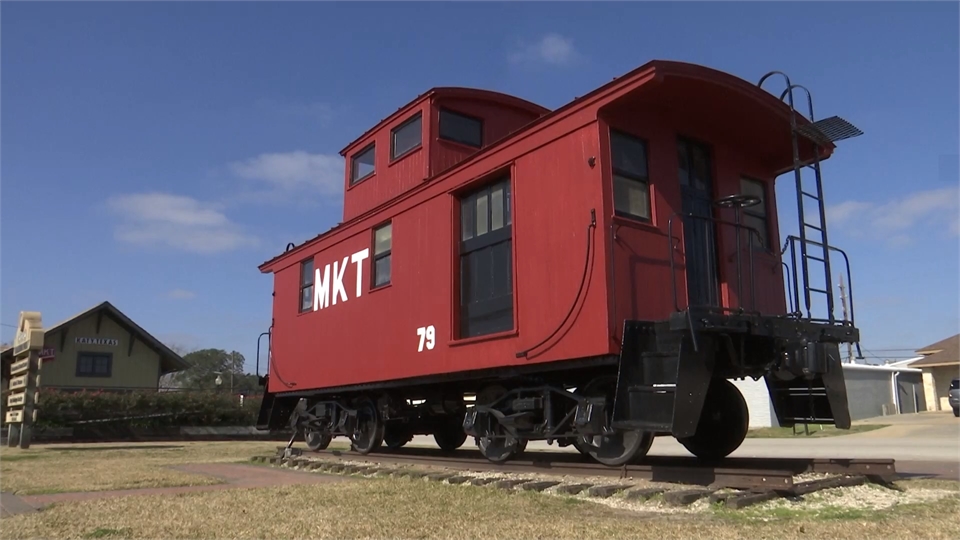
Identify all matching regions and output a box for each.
[270,118,610,391]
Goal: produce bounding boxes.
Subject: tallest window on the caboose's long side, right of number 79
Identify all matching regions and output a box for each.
[460,177,513,338]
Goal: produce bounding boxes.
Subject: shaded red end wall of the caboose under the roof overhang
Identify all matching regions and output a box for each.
[601,93,787,346]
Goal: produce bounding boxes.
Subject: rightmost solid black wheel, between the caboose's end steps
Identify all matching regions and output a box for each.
[677,379,750,461]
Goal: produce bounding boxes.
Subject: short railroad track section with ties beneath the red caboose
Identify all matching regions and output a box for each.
[253,447,897,509]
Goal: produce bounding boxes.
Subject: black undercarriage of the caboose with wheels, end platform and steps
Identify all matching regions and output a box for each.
[263,310,859,466]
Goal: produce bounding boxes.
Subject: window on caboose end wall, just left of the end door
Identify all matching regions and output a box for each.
[610,130,650,221]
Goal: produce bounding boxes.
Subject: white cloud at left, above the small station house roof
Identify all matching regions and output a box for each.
[107,192,257,253]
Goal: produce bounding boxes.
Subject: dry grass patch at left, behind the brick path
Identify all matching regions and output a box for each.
[0,441,304,495]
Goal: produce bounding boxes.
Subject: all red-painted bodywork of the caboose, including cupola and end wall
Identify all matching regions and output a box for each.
[261,61,832,392]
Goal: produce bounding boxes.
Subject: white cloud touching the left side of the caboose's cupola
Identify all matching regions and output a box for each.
[230,150,344,198]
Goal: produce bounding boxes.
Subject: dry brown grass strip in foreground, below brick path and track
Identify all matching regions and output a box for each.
[3,478,960,540]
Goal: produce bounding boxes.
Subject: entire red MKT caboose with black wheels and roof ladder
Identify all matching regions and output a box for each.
[257,60,862,466]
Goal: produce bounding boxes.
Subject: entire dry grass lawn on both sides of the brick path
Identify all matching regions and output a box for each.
[0,443,960,540]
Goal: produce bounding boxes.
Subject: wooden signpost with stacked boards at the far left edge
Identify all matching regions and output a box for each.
[4,311,43,448]
